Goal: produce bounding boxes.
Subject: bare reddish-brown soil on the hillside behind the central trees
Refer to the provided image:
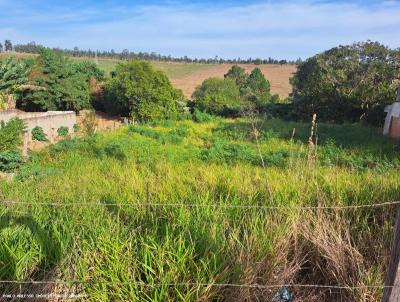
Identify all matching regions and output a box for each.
[170,64,296,98]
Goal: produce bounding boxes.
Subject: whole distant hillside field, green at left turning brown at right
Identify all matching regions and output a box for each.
[0,53,296,98]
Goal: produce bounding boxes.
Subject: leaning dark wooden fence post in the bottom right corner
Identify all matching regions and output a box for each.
[382,207,400,302]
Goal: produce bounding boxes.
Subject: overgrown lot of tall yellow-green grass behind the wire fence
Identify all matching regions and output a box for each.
[0,119,400,301]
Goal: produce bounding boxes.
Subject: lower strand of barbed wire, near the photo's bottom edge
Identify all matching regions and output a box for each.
[0,280,400,289]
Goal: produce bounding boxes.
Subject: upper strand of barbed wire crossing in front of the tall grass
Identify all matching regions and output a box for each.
[0,200,400,210]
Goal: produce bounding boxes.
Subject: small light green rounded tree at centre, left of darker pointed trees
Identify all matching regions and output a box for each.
[192,77,241,116]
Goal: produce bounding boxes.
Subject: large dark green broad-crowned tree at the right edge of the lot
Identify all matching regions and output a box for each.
[291,41,400,125]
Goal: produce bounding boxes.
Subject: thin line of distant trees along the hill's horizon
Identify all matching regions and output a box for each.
[9,42,301,64]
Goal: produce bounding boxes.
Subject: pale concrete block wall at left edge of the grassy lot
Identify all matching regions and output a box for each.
[0,110,76,141]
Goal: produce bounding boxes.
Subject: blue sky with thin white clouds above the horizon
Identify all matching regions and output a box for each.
[0,0,400,59]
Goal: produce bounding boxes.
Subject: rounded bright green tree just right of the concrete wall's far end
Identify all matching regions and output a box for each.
[104,60,184,121]
